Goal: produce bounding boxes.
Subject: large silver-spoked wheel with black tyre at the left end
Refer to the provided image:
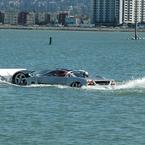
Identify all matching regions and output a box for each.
[12,72,27,86]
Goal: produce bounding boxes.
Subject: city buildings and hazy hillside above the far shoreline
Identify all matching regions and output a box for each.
[0,0,145,27]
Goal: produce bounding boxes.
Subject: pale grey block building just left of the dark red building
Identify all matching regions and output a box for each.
[4,11,18,25]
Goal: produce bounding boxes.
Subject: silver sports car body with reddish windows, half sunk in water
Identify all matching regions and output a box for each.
[32,69,87,87]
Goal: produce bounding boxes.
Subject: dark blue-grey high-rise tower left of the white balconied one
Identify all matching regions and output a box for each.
[92,0,123,25]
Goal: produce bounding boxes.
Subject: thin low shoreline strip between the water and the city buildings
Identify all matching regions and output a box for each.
[0,25,145,32]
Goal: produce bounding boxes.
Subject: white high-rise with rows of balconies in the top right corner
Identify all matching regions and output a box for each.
[123,0,145,24]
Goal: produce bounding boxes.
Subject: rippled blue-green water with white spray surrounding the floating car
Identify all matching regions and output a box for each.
[0,30,145,145]
